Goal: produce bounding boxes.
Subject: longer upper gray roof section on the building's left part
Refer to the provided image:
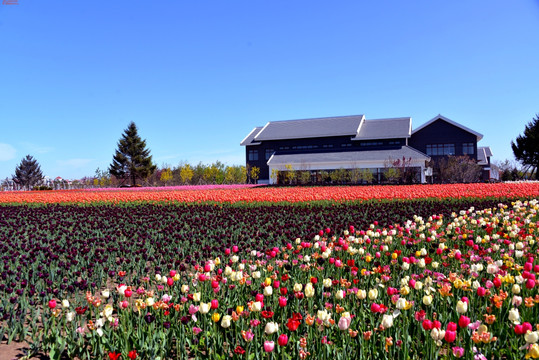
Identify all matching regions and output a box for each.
[254,115,365,141]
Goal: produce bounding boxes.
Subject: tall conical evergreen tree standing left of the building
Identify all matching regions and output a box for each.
[109,122,156,186]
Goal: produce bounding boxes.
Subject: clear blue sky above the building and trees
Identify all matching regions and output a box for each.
[0,0,539,179]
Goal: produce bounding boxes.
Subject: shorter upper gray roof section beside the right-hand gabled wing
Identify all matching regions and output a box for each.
[352,117,412,140]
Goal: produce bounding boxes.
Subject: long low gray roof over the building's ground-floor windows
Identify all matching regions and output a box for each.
[268,146,430,166]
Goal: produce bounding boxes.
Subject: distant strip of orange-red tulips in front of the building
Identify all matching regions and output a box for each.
[0,182,539,203]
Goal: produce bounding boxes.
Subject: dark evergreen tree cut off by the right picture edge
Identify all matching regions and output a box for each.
[511,114,539,177]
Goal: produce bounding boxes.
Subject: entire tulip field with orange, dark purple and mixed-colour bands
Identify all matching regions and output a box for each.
[0,183,539,360]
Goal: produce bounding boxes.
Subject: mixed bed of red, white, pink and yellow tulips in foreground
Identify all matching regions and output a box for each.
[2,201,539,359]
